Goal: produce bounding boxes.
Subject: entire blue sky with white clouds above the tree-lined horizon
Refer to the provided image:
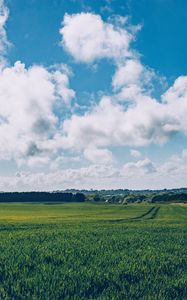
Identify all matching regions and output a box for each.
[0,0,187,191]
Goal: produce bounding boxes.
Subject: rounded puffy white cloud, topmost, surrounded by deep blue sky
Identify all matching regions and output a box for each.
[60,13,134,63]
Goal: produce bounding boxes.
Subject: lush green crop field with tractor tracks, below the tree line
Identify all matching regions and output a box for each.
[0,203,187,300]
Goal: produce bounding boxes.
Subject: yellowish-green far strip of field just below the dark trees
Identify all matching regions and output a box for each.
[0,203,152,223]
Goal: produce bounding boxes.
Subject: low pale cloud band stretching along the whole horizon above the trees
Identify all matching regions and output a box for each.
[0,152,187,191]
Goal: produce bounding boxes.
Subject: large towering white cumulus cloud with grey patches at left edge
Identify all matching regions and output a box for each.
[0,61,74,162]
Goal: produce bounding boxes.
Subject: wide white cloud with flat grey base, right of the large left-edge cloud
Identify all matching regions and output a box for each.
[59,95,181,148]
